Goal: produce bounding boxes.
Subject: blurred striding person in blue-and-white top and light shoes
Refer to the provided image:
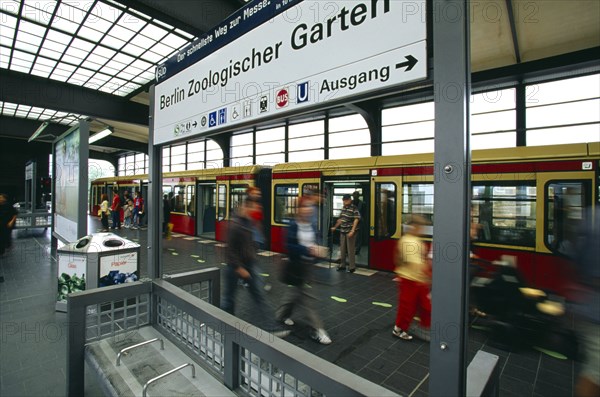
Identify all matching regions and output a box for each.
[276,197,331,345]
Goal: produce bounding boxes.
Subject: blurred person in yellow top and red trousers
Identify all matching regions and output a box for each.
[392,215,431,341]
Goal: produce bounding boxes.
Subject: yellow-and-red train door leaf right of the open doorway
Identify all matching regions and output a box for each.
[369,176,402,271]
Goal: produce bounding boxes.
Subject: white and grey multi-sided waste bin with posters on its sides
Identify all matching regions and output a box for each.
[56,233,140,311]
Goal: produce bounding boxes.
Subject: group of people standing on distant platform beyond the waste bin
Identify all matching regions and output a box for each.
[98,189,145,232]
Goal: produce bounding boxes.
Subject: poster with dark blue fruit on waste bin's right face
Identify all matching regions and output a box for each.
[98,252,140,287]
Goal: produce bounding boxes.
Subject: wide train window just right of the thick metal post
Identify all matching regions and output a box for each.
[471,182,537,247]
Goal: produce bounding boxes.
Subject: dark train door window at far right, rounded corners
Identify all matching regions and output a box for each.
[544,181,591,256]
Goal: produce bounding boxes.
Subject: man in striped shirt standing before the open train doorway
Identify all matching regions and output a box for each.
[331,194,360,273]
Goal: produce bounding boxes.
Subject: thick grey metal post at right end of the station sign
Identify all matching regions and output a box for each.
[429,0,471,396]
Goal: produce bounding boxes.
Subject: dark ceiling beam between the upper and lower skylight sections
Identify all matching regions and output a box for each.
[0,69,149,125]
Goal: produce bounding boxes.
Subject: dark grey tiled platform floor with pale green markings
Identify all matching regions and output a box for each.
[0,218,576,397]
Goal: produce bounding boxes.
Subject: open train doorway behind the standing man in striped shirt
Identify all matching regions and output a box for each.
[322,180,371,266]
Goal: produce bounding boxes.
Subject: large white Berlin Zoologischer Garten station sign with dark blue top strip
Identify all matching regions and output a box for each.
[153,0,427,145]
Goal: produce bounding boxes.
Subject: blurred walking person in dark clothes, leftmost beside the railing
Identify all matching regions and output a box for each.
[221,194,289,336]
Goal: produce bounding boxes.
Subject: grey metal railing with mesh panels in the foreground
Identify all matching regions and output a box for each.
[67,268,396,397]
